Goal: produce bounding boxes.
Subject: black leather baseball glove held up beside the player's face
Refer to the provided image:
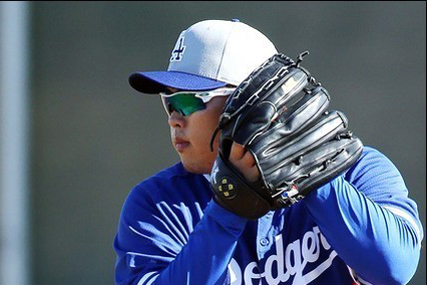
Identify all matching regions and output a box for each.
[211,52,363,219]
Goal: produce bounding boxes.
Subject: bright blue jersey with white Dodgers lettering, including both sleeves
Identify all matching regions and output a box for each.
[114,147,423,285]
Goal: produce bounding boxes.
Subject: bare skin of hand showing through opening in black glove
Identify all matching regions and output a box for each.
[229,142,260,182]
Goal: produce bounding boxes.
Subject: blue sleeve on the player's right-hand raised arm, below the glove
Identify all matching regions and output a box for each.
[304,147,423,284]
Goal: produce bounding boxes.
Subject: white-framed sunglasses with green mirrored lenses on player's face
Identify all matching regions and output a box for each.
[160,87,235,117]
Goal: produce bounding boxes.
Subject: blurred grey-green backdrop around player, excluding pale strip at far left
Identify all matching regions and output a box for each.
[4,1,426,285]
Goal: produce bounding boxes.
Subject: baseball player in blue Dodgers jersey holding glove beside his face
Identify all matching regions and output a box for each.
[114,20,423,285]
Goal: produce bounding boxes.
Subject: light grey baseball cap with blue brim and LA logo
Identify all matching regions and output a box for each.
[129,20,277,94]
